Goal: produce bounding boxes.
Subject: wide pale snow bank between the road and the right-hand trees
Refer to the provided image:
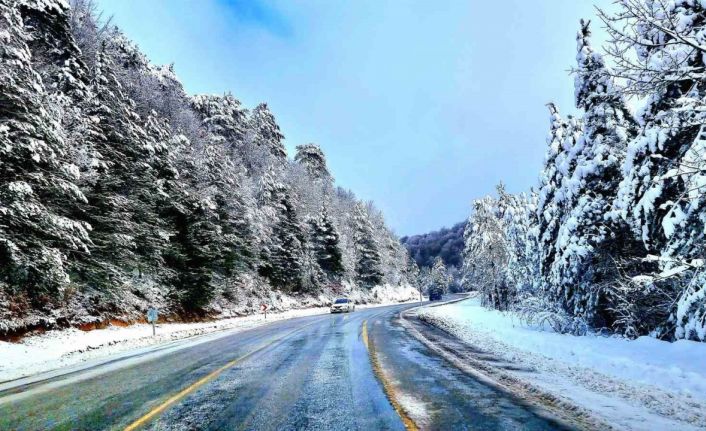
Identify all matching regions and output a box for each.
[419,298,706,430]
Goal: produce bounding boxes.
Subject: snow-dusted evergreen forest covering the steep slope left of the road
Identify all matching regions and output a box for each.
[0,0,414,334]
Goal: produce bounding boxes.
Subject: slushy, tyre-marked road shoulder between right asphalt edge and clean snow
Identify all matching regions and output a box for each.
[410,298,706,430]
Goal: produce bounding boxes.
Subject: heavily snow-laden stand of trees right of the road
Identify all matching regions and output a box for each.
[463,0,706,341]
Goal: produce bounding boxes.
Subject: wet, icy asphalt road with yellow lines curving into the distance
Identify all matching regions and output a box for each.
[0,305,565,430]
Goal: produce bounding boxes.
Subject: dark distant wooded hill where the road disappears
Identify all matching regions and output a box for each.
[401,221,466,268]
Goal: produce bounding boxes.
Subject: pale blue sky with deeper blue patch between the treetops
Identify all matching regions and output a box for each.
[98,0,612,235]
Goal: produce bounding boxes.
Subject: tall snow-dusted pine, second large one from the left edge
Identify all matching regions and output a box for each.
[73,40,166,285]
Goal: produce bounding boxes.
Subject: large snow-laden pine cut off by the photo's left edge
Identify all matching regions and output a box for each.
[0,2,90,301]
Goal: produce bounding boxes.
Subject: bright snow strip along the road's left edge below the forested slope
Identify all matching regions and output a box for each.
[0,285,418,382]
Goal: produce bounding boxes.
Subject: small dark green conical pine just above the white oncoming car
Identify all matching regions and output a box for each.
[309,202,343,280]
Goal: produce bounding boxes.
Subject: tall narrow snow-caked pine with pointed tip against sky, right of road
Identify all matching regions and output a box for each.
[550,20,635,325]
